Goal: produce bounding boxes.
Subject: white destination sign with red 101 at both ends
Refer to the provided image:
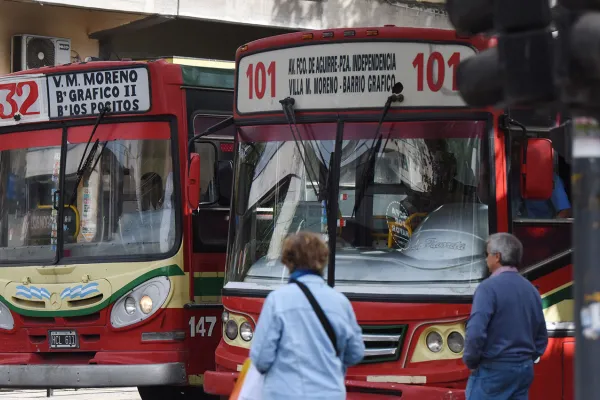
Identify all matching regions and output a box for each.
[236,41,475,114]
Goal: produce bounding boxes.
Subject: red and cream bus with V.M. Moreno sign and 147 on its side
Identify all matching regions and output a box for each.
[0,59,234,400]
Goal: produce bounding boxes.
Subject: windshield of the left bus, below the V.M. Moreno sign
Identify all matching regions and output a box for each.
[0,122,176,263]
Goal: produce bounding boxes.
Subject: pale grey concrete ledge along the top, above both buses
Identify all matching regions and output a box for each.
[16,0,451,29]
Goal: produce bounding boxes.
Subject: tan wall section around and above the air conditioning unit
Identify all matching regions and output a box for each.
[0,0,143,75]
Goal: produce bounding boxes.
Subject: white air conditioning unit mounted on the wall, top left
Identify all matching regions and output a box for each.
[11,35,71,72]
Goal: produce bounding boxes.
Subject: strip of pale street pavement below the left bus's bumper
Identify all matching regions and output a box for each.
[0,388,140,400]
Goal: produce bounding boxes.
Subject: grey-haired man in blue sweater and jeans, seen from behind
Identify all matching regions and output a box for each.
[463,233,548,400]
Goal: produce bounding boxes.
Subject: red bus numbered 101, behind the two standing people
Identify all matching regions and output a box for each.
[204,26,573,400]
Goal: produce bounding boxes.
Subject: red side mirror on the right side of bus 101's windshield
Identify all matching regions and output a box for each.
[521,138,554,200]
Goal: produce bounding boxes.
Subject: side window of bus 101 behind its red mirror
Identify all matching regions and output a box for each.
[510,140,572,267]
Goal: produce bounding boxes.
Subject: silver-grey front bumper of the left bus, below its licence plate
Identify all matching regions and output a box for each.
[0,362,187,388]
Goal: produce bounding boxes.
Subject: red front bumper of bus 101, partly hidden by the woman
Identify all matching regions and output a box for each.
[204,371,465,400]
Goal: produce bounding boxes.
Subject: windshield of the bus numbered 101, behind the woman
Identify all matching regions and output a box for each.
[226,121,490,295]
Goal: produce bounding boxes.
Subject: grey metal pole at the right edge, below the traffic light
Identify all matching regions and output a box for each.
[571,117,600,400]
